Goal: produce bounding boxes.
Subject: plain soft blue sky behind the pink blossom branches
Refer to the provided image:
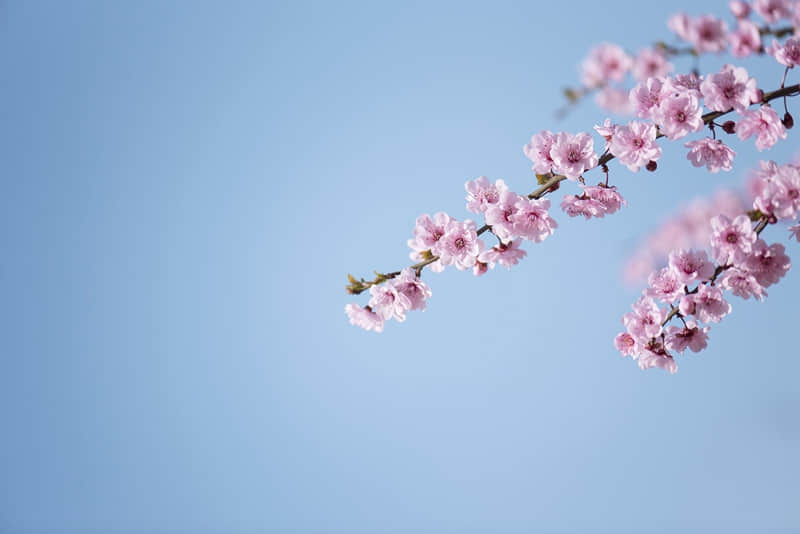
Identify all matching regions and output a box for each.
[0,0,800,533]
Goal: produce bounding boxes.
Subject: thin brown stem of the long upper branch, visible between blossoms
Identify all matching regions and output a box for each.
[345,84,800,295]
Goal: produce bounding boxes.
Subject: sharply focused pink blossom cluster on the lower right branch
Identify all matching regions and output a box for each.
[614,161,800,373]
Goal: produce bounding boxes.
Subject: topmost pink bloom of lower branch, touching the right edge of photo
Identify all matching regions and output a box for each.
[753,162,800,219]
